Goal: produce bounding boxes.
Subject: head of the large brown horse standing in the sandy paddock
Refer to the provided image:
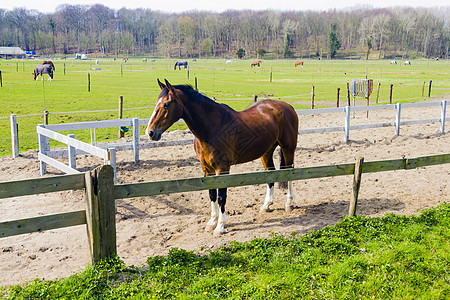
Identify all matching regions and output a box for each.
[145,79,183,141]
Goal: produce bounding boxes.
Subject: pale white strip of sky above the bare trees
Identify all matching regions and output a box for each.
[0,0,450,13]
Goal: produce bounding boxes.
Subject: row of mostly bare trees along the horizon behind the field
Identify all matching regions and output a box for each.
[0,4,450,59]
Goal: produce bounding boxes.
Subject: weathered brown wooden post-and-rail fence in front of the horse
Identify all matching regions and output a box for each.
[0,154,450,263]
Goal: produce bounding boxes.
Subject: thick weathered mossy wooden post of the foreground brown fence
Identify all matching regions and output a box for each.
[85,165,117,264]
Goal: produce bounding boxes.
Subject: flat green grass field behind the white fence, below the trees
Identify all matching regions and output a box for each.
[0,59,450,156]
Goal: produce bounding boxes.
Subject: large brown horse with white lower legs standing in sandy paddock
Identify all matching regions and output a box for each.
[145,80,298,234]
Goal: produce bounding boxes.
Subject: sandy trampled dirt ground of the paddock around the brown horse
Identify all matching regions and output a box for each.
[0,103,450,285]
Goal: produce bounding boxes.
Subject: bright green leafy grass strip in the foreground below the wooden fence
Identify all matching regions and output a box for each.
[4,203,450,299]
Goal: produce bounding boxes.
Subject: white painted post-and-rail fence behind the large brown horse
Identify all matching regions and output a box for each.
[6,100,449,179]
